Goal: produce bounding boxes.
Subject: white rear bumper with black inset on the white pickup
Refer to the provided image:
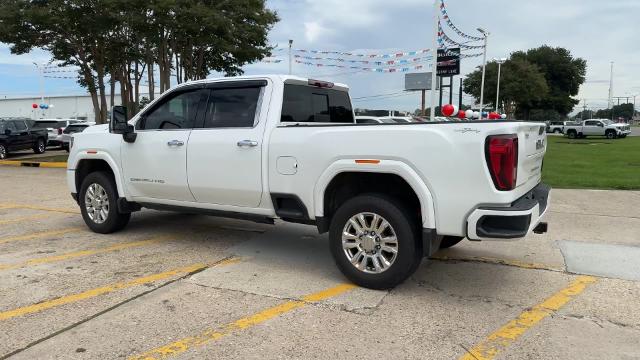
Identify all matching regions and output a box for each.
[467,183,551,240]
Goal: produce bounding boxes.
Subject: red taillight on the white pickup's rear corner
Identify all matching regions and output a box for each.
[485,134,518,191]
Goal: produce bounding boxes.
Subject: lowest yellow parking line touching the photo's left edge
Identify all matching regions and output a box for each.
[0,264,212,321]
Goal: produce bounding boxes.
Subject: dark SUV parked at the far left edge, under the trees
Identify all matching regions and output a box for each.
[0,118,47,160]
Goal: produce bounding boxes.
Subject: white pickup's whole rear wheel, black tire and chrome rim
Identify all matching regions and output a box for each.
[329,194,423,289]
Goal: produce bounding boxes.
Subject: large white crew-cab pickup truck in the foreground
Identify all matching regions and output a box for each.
[67,75,550,289]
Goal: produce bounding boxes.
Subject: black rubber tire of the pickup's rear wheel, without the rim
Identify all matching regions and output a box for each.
[329,194,423,290]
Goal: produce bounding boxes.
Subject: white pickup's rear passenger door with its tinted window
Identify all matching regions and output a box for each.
[187,82,267,207]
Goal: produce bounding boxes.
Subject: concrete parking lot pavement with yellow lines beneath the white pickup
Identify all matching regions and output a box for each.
[0,167,640,359]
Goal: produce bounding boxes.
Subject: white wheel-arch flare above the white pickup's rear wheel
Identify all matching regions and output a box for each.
[313,159,436,229]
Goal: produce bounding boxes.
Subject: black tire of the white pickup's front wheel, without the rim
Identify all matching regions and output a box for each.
[78,171,131,234]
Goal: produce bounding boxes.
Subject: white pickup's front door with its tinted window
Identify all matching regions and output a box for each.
[122,88,206,201]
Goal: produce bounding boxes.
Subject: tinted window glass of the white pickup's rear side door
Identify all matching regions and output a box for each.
[204,87,262,129]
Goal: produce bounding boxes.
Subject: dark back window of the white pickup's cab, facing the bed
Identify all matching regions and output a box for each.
[280,84,353,123]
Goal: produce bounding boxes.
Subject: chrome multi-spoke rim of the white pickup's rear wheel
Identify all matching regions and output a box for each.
[342,213,398,274]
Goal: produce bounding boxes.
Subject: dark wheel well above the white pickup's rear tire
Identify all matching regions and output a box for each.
[318,172,422,232]
